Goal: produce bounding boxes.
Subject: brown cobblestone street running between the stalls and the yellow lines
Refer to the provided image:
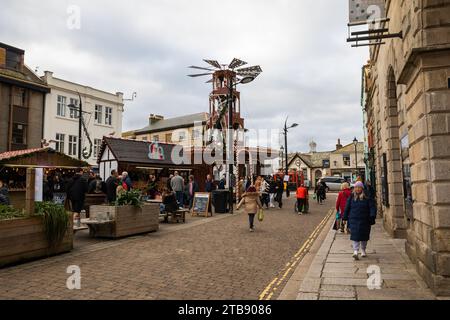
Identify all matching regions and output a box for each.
[0,195,335,299]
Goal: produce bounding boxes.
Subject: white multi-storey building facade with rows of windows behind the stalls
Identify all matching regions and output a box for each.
[42,71,124,166]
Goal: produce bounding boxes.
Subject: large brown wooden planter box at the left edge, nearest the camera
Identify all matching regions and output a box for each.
[0,214,73,267]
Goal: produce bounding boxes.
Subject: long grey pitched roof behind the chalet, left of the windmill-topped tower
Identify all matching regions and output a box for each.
[135,112,209,134]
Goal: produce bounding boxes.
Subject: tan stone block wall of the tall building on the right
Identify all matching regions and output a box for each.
[367,0,450,295]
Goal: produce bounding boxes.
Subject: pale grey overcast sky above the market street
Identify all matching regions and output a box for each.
[0,0,368,151]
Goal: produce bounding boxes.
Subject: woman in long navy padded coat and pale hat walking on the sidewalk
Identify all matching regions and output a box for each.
[344,182,377,260]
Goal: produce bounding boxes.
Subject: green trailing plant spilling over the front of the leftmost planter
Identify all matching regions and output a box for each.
[35,202,70,247]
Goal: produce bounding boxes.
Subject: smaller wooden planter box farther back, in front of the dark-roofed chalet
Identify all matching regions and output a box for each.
[88,204,159,239]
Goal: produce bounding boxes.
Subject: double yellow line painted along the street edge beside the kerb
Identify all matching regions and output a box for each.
[259,210,334,300]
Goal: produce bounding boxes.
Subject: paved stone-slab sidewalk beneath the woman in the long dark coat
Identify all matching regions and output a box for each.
[297,220,436,300]
